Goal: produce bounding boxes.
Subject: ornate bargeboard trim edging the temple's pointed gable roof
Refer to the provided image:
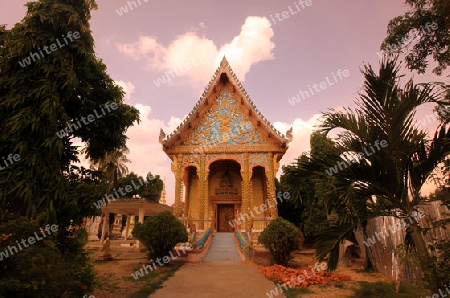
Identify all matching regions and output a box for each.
[159,56,292,149]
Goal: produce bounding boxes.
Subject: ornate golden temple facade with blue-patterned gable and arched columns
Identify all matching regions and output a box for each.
[159,58,292,232]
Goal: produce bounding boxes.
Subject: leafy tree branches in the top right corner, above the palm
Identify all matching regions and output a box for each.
[381,0,450,75]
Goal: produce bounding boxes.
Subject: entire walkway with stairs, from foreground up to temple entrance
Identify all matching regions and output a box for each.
[150,233,276,298]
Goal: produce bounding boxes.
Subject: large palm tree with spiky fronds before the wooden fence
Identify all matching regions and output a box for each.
[304,58,450,290]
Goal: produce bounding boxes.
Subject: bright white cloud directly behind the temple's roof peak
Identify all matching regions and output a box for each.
[117,16,275,88]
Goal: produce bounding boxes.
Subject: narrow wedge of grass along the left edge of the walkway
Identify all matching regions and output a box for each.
[123,265,181,298]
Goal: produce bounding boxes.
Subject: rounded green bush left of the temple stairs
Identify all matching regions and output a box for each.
[132,211,188,260]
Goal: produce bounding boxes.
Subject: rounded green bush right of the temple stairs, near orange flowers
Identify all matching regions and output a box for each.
[258,217,303,266]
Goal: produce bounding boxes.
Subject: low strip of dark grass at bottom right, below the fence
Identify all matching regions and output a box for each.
[354,281,428,298]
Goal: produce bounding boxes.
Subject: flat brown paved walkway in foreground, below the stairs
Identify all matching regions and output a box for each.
[149,263,278,298]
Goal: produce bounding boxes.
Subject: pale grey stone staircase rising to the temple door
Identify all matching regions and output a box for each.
[203,233,241,263]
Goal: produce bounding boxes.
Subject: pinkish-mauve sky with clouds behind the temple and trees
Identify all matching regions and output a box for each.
[0,0,444,204]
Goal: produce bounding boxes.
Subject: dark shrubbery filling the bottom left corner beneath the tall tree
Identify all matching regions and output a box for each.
[0,217,94,298]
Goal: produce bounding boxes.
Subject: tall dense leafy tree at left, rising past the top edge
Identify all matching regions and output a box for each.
[0,0,139,216]
